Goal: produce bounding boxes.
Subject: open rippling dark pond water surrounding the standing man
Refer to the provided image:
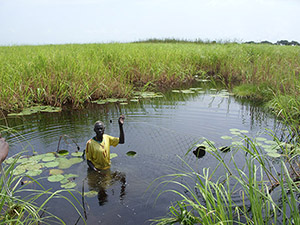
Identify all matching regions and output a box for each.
[2,87,278,224]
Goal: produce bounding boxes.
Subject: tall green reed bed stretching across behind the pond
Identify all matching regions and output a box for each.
[0,43,300,116]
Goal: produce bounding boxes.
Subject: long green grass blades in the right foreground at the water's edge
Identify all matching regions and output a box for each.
[150,129,300,225]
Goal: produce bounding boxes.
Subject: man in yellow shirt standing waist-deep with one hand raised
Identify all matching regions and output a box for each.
[85,115,125,172]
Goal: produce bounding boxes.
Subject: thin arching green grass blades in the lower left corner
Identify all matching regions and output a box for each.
[0,158,85,224]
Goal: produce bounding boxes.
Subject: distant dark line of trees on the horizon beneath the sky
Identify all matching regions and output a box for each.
[136,38,300,46]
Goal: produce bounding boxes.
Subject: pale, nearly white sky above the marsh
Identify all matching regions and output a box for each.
[0,0,300,45]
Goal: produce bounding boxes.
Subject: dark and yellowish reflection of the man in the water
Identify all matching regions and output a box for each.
[87,168,126,205]
